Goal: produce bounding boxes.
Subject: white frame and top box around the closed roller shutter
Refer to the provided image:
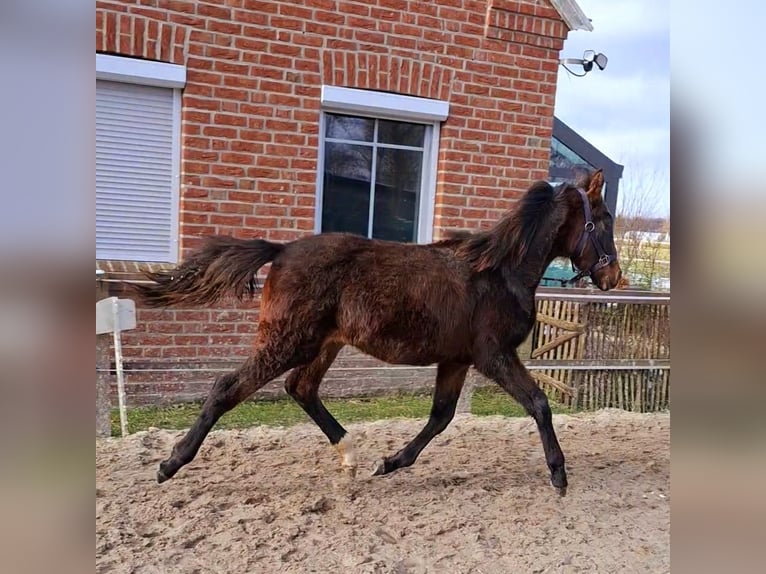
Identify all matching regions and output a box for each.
[96,54,186,263]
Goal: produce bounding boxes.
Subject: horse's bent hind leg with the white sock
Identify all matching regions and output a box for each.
[285,341,356,476]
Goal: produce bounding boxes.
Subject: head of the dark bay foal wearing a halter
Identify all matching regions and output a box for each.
[558,169,622,291]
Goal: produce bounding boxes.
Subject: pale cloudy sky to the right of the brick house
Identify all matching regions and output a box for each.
[556,0,670,216]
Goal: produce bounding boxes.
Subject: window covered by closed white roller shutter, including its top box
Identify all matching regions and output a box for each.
[96,54,185,263]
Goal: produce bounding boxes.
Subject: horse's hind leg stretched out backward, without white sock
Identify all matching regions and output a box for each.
[157,337,304,483]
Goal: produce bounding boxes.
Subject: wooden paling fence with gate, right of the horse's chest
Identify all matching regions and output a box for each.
[521,289,670,412]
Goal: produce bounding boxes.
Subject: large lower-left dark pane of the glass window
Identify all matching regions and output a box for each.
[322,142,372,237]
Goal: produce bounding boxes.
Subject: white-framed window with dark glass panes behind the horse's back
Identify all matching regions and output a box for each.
[316,86,448,243]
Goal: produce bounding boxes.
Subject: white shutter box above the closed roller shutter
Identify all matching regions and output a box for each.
[96,54,186,88]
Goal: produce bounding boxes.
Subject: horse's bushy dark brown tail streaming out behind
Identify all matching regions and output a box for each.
[133,235,284,307]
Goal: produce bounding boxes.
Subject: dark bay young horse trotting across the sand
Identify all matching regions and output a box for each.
[136,170,622,494]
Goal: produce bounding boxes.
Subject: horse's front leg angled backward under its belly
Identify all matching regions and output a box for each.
[373,363,468,476]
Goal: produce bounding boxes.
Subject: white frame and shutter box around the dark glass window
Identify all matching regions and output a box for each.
[314,85,449,243]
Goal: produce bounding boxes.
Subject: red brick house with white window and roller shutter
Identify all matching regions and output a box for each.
[96,0,591,404]
